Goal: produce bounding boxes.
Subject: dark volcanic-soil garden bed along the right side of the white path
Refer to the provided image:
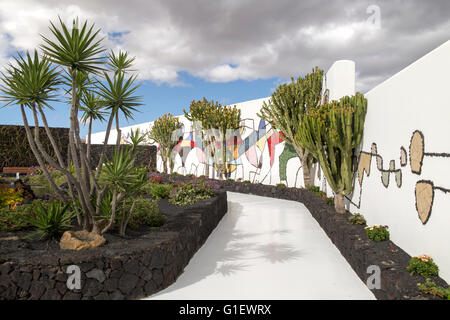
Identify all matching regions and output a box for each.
[164,175,448,300]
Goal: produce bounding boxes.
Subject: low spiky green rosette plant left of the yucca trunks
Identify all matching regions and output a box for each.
[24,200,75,239]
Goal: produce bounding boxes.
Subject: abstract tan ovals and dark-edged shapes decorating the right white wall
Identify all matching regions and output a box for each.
[347,130,450,224]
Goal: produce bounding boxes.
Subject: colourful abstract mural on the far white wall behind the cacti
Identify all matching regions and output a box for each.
[148,119,306,184]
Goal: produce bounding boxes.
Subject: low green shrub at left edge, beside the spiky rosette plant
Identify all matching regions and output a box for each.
[0,204,33,232]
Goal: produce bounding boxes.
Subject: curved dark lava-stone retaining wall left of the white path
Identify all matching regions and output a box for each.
[0,192,227,300]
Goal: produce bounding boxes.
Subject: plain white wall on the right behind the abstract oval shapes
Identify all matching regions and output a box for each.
[350,41,450,281]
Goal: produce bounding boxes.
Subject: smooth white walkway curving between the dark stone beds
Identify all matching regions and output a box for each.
[147,192,375,300]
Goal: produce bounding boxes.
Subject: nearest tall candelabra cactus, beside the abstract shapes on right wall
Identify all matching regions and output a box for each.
[295,93,367,213]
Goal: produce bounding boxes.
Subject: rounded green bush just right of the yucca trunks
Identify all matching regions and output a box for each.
[126,198,167,229]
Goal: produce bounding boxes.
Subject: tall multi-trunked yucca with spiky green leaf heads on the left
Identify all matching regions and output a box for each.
[1,19,141,233]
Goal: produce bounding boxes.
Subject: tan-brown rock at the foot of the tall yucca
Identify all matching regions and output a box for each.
[59,230,106,250]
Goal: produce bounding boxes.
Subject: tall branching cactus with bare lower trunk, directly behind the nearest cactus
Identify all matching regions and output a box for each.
[258,67,323,186]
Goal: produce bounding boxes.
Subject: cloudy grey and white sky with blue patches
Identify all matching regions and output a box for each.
[0,0,450,134]
